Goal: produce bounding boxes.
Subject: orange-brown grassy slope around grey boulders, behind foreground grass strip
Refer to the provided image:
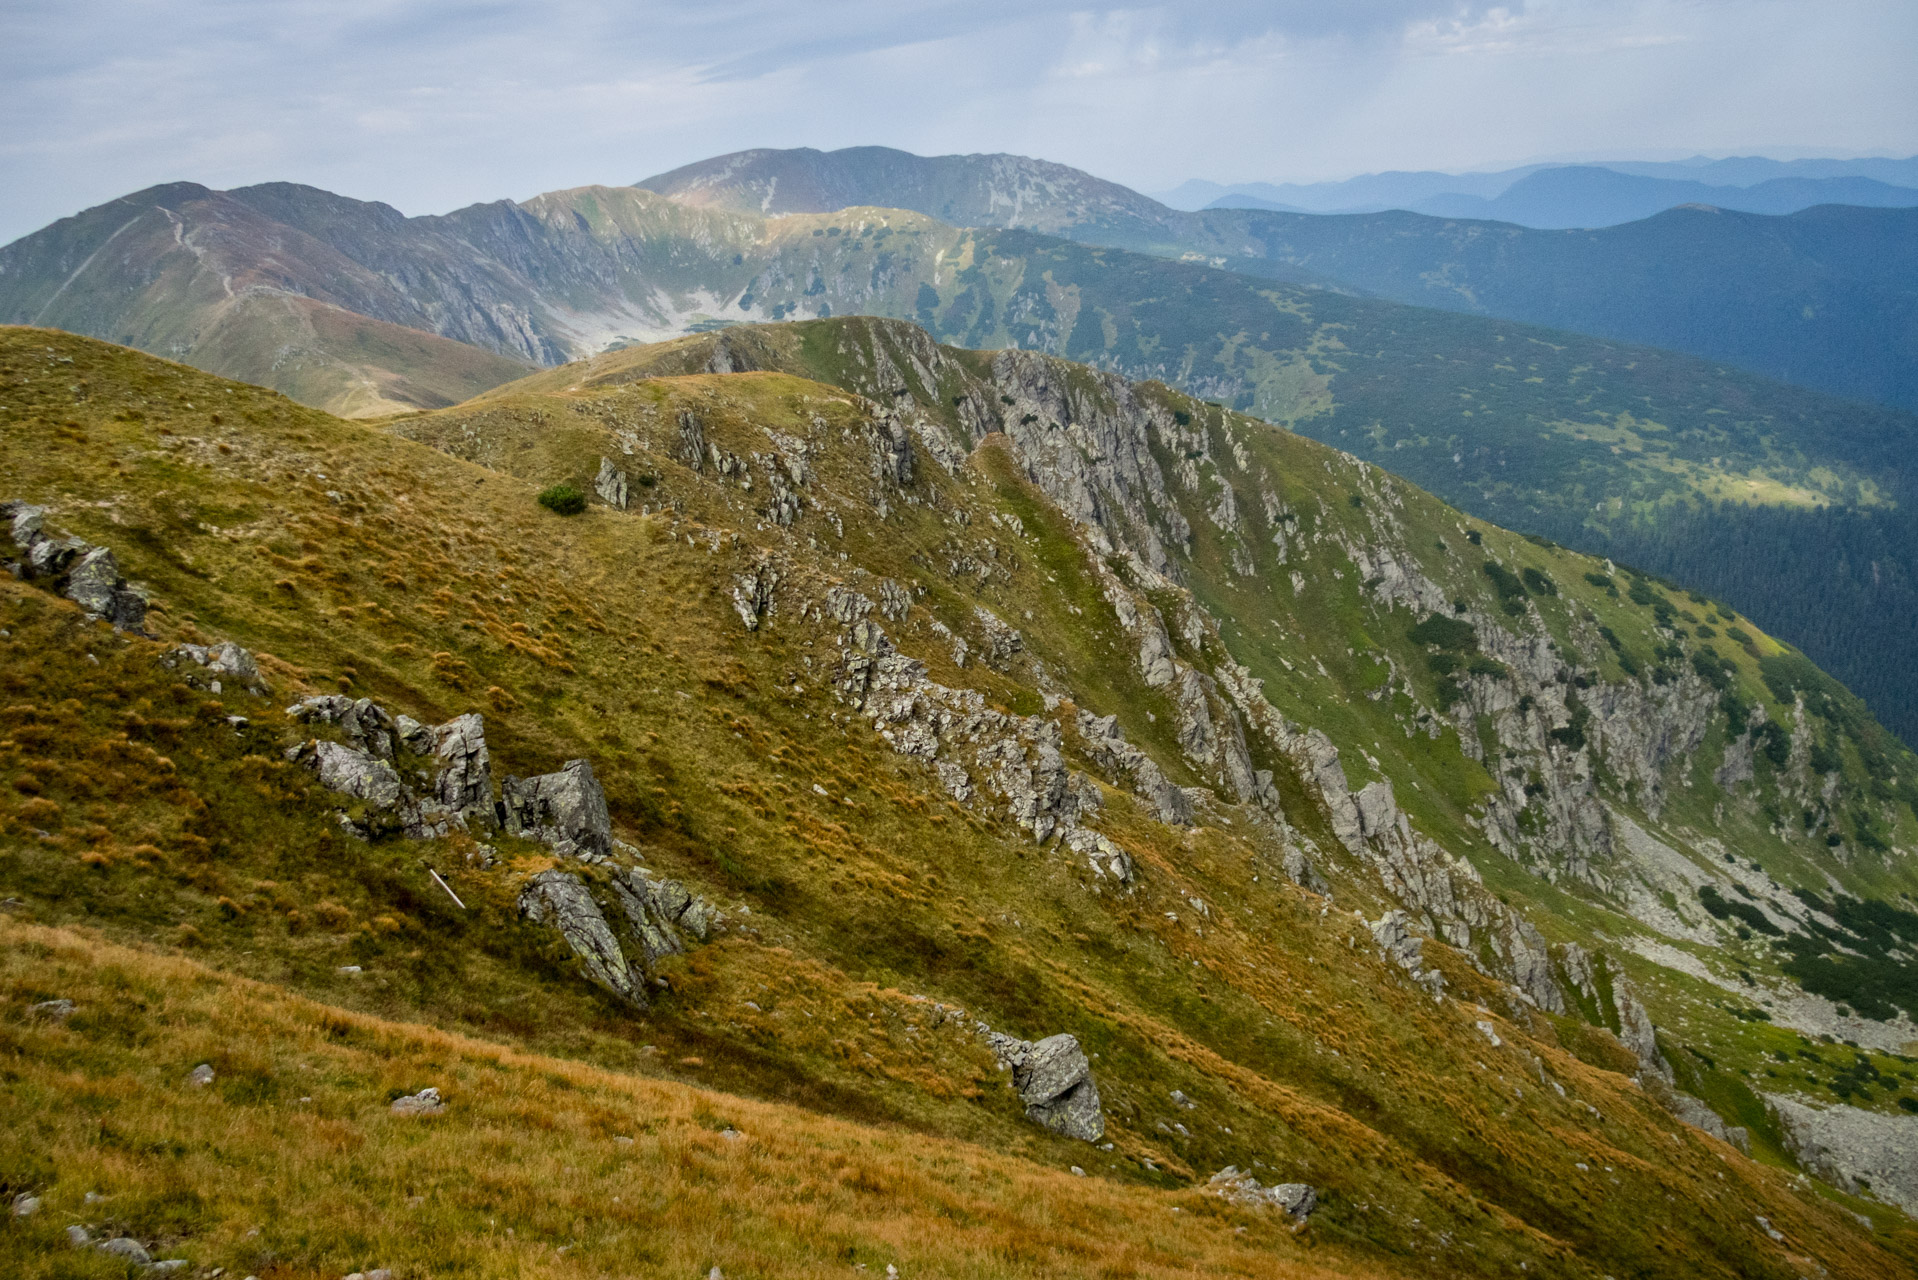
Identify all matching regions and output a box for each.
[0,330,1912,1276]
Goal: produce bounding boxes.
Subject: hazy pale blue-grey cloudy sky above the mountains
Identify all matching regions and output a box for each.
[0,0,1918,244]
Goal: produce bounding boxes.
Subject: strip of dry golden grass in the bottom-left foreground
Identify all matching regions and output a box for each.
[0,917,1380,1280]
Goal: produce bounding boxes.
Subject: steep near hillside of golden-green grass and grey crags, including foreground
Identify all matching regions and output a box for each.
[0,320,1918,1278]
